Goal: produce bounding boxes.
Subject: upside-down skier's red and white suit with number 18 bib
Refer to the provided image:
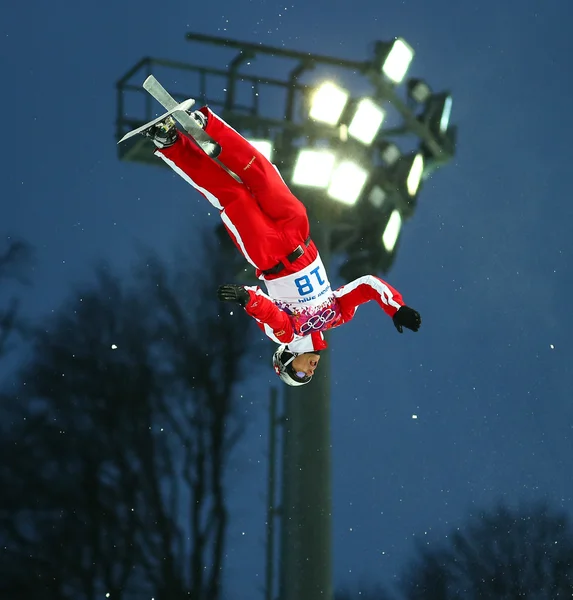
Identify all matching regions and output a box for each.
[155,107,404,352]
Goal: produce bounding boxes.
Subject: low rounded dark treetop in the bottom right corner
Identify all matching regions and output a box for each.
[403,504,573,600]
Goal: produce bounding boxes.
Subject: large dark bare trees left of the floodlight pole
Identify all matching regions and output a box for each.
[0,233,252,600]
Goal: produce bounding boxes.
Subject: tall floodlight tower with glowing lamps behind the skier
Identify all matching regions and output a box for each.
[117,33,456,600]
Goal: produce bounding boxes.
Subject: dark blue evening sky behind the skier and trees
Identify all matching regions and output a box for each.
[0,0,573,600]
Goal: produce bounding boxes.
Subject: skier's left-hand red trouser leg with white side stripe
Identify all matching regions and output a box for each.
[155,135,296,270]
